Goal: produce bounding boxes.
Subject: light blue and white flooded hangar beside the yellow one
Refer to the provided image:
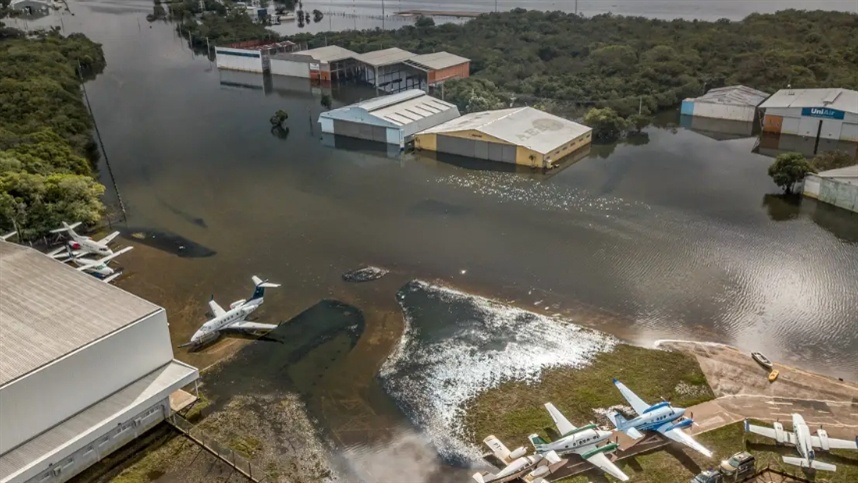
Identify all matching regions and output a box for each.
[319,89,459,148]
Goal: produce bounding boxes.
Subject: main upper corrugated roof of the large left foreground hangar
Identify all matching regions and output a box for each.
[0,241,162,386]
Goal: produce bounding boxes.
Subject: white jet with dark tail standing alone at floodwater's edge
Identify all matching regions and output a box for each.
[179,275,280,348]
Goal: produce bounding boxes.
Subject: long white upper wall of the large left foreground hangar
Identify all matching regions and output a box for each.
[0,309,173,454]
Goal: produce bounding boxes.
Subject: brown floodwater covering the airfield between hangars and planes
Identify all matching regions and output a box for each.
[41,1,858,478]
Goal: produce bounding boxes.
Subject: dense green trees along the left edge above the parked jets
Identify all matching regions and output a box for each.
[0,22,105,239]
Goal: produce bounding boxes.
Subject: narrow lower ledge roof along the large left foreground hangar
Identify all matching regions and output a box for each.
[0,362,199,480]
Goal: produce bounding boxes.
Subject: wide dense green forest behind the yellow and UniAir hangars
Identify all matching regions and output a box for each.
[293,9,858,117]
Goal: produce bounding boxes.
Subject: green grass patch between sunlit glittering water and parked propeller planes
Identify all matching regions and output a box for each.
[464,344,714,447]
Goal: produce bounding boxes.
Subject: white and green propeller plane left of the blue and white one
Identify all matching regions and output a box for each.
[528,403,629,481]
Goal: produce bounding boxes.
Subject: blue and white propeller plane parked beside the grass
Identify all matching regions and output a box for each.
[608,379,712,458]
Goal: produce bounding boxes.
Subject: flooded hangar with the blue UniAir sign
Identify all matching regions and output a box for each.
[760,89,858,142]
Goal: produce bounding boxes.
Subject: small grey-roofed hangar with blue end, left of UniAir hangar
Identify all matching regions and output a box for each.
[681,86,769,122]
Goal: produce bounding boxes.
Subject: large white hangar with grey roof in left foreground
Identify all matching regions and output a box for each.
[0,241,199,483]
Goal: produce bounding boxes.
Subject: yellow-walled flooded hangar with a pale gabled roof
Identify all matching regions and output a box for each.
[414,107,593,168]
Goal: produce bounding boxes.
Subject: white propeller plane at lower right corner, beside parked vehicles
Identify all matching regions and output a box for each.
[745,413,858,471]
